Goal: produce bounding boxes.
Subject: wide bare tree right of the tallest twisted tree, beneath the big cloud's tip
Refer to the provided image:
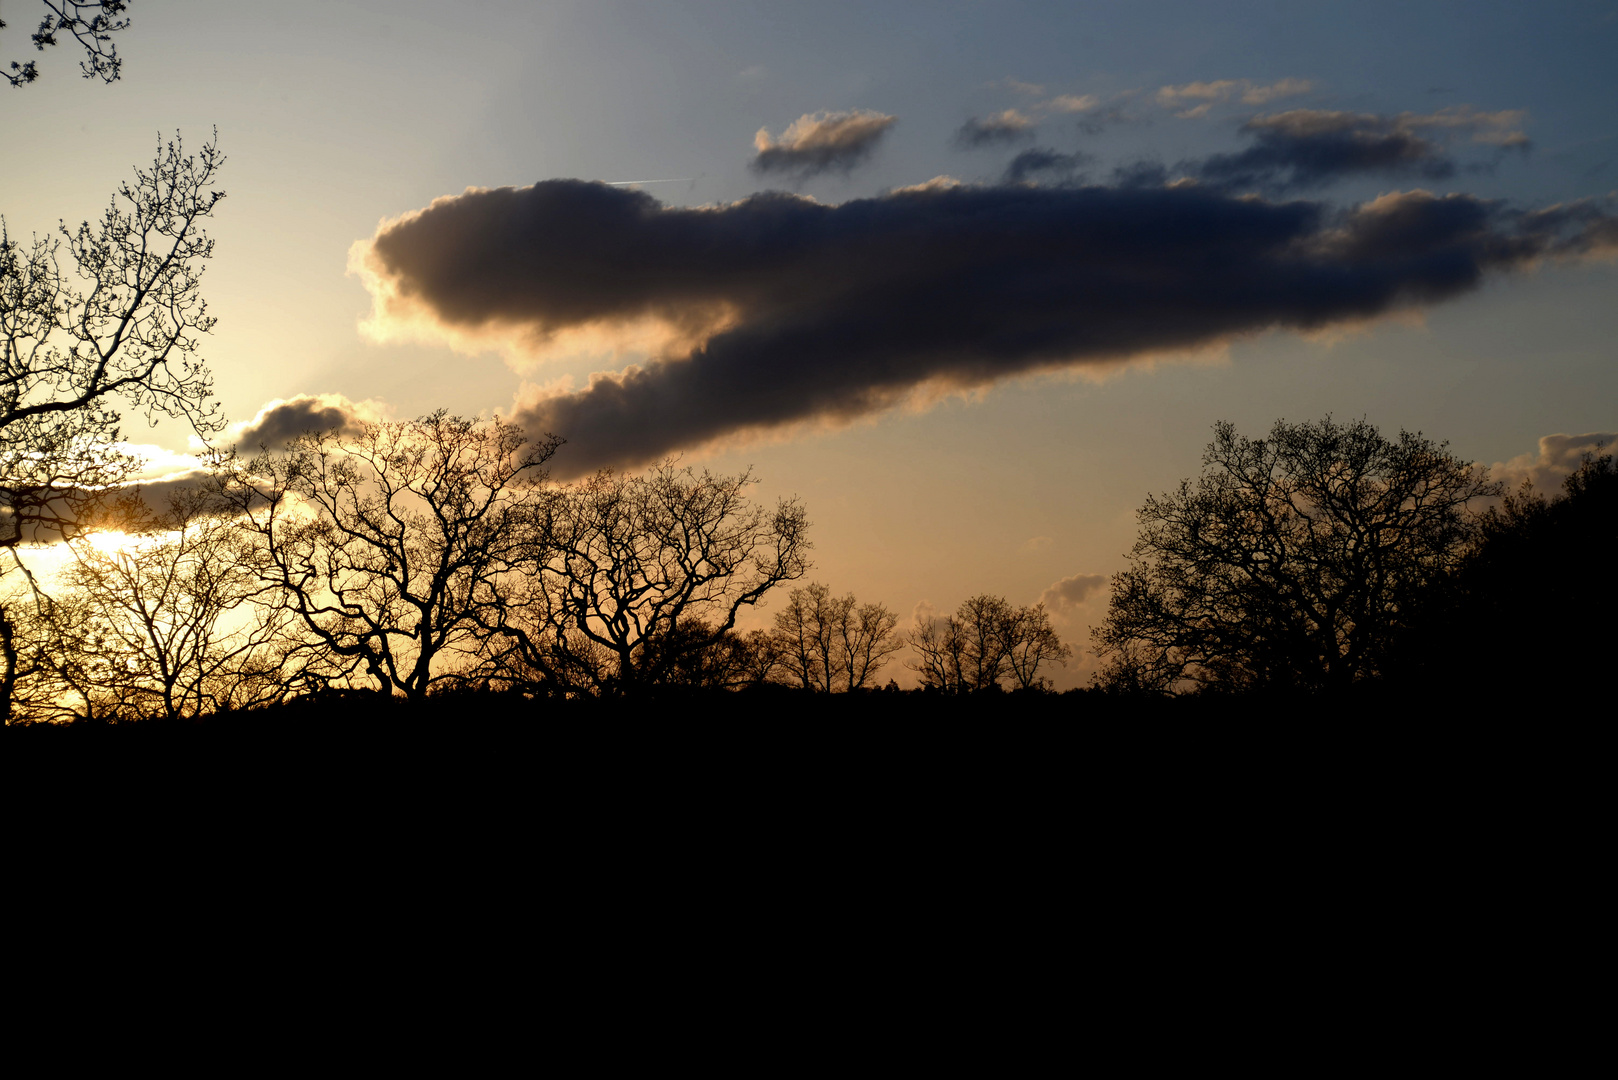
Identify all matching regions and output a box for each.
[497,463,809,695]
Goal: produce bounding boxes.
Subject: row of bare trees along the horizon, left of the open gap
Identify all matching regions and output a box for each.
[0,413,1069,721]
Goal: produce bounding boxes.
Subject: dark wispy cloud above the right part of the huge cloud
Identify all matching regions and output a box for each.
[1180,108,1527,194]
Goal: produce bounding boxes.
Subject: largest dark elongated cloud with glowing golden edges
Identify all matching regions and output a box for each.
[354,180,1618,474]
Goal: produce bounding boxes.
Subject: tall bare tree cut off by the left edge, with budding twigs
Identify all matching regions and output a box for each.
[0,139,225,714]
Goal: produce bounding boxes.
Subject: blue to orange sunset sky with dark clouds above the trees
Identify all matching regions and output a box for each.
[0,0,1618,687]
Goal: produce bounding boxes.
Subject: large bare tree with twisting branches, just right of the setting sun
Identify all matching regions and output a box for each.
[220,411,560,698]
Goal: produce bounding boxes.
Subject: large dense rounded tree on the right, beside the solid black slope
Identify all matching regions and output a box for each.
[1095,418,1500,690]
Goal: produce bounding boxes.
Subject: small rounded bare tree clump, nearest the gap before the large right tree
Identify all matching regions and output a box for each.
[909,593,1073,693]
